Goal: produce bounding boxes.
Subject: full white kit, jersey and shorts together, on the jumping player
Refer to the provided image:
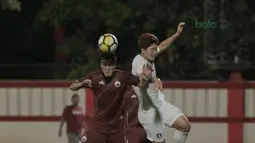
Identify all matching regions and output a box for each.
[132,52,183,142]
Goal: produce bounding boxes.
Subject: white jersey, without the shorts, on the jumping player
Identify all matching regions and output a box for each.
[132,55,165,109]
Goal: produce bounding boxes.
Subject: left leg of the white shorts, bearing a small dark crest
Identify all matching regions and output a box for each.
[138,109,165,143]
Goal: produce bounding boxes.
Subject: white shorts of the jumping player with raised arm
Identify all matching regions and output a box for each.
[138,101,183,142]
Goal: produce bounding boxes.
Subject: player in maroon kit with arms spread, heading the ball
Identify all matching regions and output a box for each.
[70,54,152,143]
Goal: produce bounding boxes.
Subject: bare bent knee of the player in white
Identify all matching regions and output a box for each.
[172,115,191,132]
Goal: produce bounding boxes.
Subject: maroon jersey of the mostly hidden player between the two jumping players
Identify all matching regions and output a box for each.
[124,86,142,128]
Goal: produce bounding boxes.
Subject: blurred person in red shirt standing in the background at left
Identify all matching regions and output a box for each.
[58,94,85,143]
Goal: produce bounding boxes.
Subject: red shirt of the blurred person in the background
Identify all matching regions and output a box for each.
[62,105,84,133]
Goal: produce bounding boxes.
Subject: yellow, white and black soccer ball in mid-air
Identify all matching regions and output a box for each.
[98,33,118,53]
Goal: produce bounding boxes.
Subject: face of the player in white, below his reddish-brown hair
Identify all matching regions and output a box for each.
[142,44,158,61]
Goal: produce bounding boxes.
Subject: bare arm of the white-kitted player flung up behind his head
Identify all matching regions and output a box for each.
[158,22,185,53]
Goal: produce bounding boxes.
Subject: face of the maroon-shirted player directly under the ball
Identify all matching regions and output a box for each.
[100,60,115,77]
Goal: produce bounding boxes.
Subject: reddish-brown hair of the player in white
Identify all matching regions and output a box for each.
[138,33,159,49]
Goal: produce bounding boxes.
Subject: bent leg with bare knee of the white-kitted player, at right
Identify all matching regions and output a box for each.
[160,102,191,143]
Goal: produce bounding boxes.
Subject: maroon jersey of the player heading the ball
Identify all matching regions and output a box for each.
[81,70,140,133]
